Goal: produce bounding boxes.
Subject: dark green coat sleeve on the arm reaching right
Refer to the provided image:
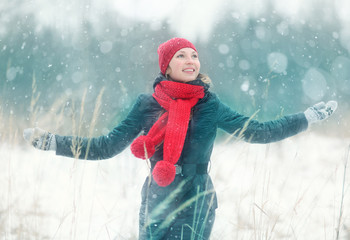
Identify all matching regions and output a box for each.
[218,101,308,143]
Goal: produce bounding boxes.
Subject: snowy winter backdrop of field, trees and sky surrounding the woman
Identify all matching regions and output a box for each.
[0,0,350,240]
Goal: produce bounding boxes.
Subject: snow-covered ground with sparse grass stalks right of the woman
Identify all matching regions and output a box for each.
[211,133,350,239]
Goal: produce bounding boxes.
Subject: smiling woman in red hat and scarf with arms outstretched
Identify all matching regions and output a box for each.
[24,38,337,239]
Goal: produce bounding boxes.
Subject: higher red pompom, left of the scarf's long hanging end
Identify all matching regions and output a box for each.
[130,135,156,159]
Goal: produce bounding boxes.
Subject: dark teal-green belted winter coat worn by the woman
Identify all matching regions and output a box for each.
[56,76,308,239]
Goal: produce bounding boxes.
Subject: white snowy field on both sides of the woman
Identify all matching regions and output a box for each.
[0,131,350,240]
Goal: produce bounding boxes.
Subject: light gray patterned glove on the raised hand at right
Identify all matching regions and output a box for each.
[304,101,338,124]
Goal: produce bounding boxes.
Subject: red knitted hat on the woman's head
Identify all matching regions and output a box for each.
[157,38,197,74]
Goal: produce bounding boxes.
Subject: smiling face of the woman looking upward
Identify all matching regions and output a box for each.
[166,48,201,82]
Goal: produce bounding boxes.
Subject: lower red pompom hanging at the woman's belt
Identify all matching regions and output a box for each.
[152,160,176,187]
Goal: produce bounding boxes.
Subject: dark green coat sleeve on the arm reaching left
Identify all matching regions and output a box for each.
[55,95,144,160]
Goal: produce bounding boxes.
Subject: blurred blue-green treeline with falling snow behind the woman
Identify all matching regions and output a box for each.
[0,9,350,142]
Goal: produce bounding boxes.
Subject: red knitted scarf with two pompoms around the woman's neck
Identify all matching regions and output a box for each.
[131,81,204,187]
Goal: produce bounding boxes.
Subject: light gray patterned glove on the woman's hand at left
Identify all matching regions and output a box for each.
[23,127,57,151]
